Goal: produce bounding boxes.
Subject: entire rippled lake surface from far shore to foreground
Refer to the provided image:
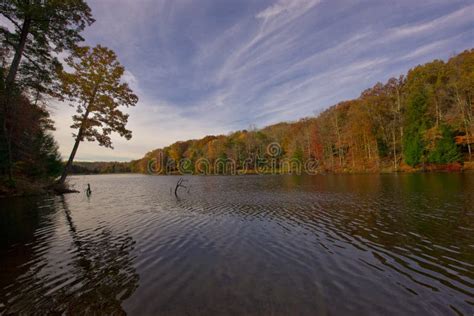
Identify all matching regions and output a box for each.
[0,174,474,316]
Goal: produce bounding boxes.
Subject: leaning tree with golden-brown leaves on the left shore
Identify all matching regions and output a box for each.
[59,45,138,184]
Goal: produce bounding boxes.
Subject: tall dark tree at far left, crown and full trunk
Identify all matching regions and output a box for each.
[0,0,94,183]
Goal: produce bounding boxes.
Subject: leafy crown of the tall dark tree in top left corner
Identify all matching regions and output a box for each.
[0,0,94,89]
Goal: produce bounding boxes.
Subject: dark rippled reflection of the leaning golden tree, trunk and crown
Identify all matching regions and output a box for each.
[56,198,139,314]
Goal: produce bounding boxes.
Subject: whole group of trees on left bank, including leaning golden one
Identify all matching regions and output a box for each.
[0,0,138,194]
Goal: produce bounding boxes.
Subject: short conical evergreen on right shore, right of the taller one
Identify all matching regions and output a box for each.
[428,125,461,164]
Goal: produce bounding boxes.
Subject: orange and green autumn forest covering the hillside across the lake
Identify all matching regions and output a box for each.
[130,49,474,173]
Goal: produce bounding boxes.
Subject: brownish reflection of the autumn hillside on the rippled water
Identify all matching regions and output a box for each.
[160,174,474,314]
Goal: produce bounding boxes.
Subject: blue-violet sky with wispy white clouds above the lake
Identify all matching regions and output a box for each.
[52,0,474,161]
